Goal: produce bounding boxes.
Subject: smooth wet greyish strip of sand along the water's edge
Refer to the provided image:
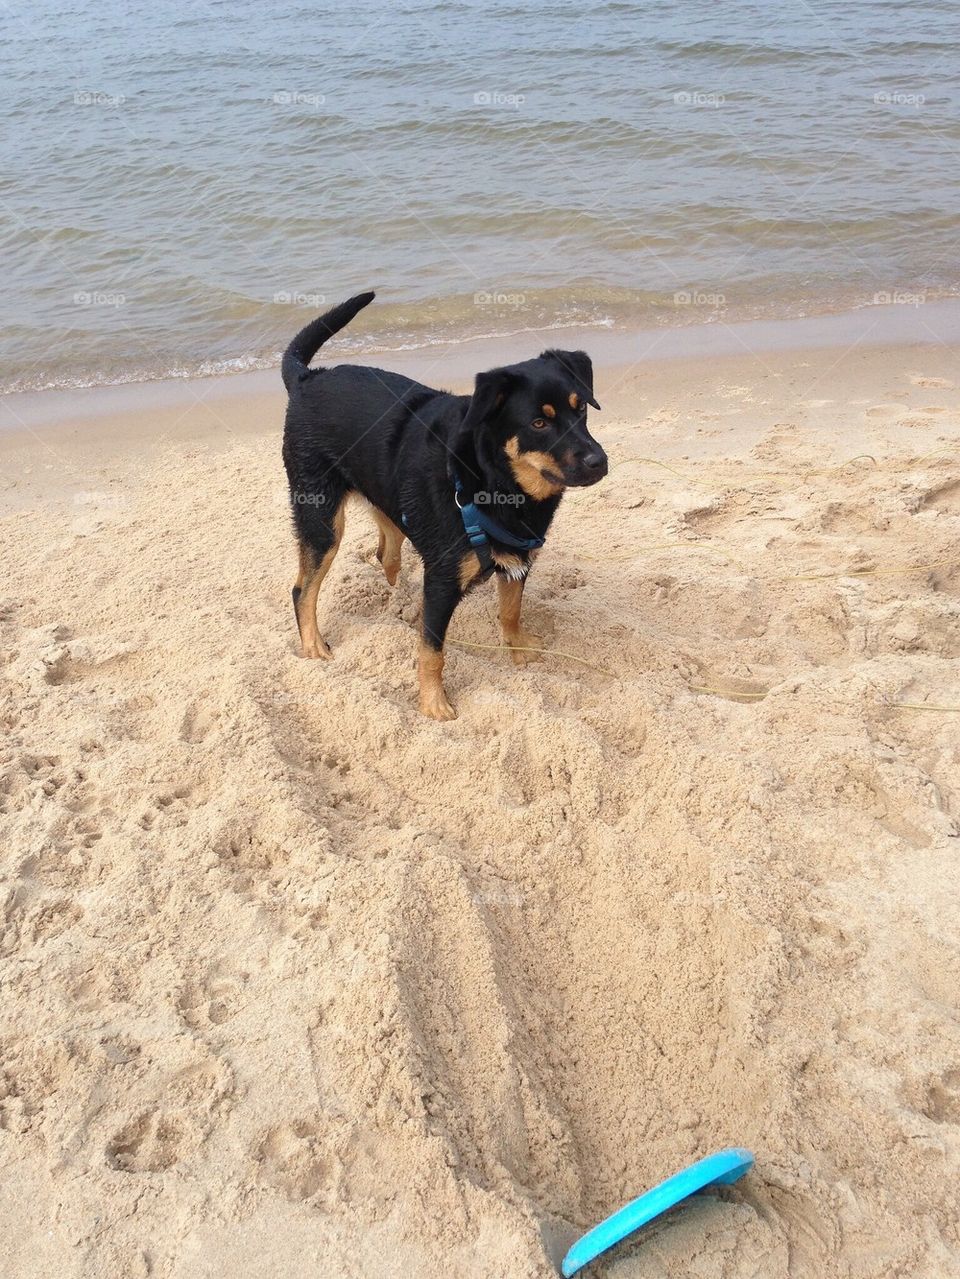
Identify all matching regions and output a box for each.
[0,299,960,441]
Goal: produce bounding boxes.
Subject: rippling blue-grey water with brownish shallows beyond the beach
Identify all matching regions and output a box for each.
[0,0,960,389]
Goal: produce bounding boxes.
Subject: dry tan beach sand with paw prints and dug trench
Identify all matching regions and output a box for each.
[0,332,960,1279]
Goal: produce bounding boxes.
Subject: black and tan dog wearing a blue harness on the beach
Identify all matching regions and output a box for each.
[283,293,607,720]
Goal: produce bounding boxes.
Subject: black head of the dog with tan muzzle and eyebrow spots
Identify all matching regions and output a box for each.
[463,350,607,498]
